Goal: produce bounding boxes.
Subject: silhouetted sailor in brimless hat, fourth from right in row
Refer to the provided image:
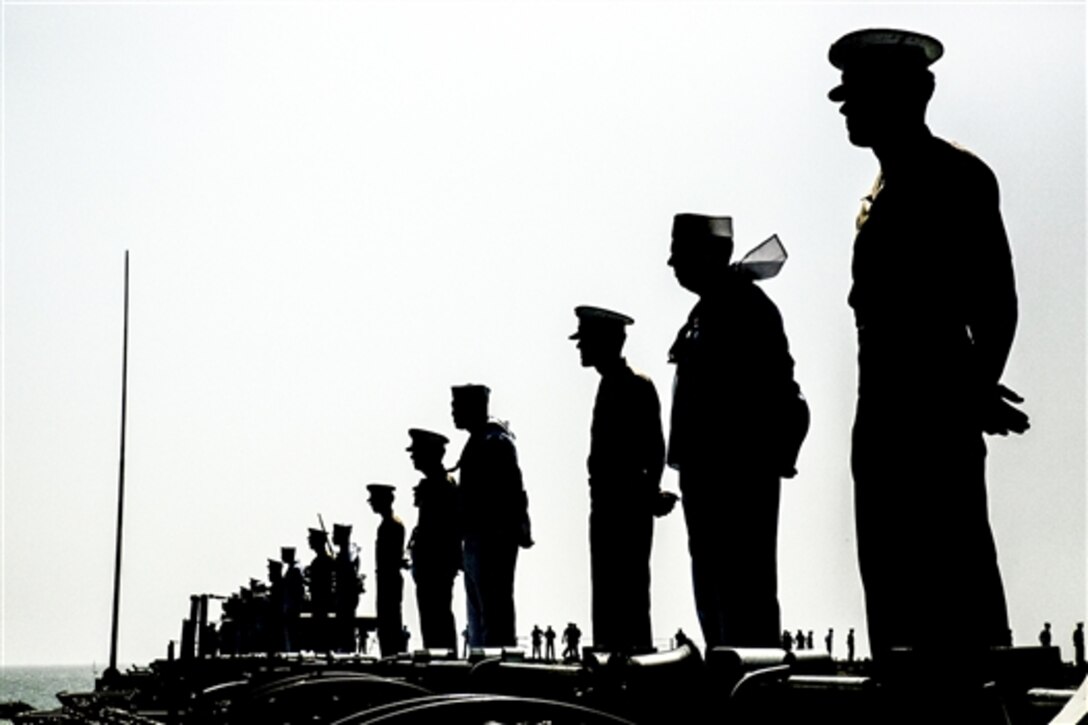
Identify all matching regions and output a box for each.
[453,384,533,647]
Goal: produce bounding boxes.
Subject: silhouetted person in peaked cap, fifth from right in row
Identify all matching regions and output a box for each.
[408,428,461,652]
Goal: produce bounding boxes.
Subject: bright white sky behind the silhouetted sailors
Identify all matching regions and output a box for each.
[0,2,1086,664]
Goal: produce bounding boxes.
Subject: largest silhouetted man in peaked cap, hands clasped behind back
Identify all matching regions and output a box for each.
[828,29,1028,658]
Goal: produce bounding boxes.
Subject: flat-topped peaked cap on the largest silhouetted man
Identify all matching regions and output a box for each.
[827,28,944,101]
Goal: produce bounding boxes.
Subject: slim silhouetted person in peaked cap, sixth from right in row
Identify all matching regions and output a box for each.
[367,483,405,658]
